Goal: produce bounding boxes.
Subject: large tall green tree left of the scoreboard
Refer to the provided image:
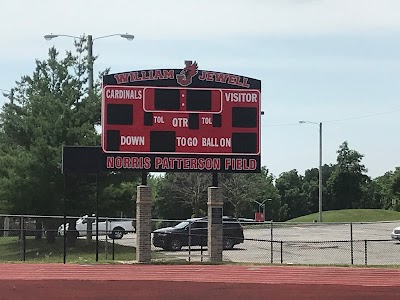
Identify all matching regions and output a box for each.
[0,41,100,214]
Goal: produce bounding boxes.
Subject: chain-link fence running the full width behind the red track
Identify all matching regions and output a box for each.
[0,215,400,265]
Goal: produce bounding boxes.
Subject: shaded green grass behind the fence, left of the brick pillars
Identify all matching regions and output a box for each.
[0,237,136,263]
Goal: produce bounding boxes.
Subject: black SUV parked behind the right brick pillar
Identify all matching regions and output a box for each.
[153,216,244,251]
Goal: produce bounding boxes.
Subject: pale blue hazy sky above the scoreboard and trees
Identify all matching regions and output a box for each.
[0,0,400,178]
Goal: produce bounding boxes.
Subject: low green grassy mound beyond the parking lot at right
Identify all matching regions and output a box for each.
[287,209,400,222]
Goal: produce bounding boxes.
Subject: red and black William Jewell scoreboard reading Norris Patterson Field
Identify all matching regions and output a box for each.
[102,62,261,172]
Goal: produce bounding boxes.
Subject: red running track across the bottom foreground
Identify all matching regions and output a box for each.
[0,264,400,300]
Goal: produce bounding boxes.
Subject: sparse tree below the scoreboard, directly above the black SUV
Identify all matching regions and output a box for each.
[155,168,279,219]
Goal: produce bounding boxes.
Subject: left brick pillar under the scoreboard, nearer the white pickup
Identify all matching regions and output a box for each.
[136,185,152,263]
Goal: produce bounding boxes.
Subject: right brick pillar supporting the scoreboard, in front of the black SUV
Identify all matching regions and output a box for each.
[207,187,224,262]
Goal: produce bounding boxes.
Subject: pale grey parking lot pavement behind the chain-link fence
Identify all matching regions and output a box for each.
[102,222,400,265]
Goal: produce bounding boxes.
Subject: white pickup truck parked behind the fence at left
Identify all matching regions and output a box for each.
[58,215,136,239]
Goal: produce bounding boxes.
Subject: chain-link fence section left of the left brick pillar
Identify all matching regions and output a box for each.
[0,215,136,263]
